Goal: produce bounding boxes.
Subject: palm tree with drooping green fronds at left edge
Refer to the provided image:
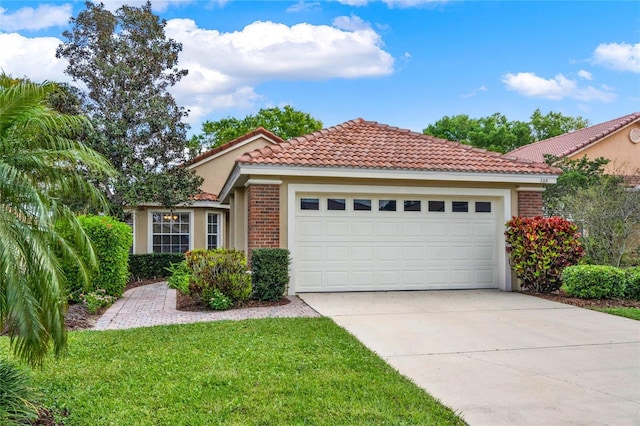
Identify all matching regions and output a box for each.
[0,74,113,365]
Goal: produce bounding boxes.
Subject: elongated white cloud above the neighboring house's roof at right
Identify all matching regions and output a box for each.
[502,72,617,102]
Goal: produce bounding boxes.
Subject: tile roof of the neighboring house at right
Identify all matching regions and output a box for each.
[508,112,640,161]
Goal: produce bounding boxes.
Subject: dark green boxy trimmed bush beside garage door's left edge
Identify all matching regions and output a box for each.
[251,248,290,301]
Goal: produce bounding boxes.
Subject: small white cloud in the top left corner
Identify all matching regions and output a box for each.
[0,4,72,32]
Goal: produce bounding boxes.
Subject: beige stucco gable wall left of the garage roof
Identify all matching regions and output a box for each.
[192,138,271,195]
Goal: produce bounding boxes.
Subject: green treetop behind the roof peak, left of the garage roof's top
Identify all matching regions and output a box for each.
[192,105,322,149]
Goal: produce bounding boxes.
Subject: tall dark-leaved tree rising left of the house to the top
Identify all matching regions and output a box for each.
[56,1,202,208]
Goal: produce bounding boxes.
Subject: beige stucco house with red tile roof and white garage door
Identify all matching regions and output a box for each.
[133,119,560,294]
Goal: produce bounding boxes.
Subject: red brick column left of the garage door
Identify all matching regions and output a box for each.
[247,184,280,262]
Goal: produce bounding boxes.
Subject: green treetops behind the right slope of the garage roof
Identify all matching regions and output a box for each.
[423,109,588,153]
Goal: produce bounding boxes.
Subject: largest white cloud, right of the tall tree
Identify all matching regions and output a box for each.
[166,17,394,122]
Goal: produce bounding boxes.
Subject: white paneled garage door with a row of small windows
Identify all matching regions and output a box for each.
[293,193,502,292]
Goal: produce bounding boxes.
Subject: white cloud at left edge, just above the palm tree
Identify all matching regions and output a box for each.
[0,33,70,82]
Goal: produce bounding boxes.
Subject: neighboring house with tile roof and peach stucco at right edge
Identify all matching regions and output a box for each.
[507,112,640,176]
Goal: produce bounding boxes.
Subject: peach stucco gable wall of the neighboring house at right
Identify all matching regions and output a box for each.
[570,123,640,175]
